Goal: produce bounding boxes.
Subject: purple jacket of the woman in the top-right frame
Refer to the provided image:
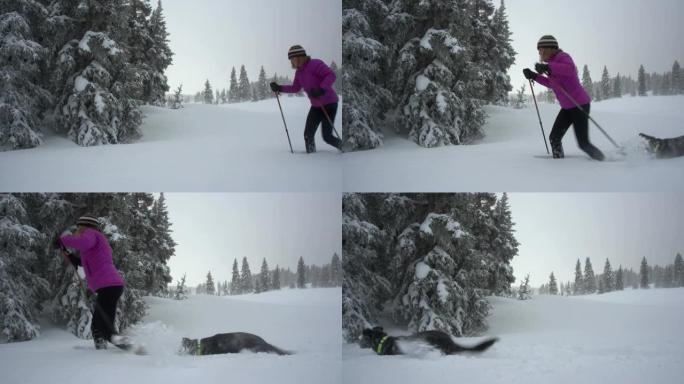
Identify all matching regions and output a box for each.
[535,51,591,109]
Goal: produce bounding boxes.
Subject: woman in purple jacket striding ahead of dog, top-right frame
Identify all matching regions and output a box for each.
[523,35,604,161]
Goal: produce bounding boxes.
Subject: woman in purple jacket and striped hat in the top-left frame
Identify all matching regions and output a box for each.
[271,45,342,153]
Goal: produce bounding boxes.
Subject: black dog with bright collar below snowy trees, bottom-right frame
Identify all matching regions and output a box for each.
[359,327,498,355]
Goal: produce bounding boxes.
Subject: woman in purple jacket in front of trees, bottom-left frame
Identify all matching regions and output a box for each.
[60,216,124,349]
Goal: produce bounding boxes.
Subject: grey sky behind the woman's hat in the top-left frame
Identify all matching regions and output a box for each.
[162,0,342,94]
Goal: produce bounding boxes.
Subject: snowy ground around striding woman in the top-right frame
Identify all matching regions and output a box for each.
[344,96,684,192]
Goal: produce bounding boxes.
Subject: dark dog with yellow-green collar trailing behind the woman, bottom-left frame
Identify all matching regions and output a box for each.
[181,332,292,355]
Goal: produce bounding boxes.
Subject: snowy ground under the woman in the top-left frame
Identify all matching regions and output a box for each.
[0,97,342,192]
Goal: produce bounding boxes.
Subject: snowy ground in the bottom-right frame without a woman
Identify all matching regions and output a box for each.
[342,288,684,384]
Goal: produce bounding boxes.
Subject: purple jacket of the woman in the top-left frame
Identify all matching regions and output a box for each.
[280,59,339,107]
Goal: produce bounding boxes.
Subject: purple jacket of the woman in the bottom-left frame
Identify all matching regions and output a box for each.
[61,228,124,291]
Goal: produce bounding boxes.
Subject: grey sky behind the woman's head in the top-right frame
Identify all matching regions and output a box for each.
[508,0,684,92]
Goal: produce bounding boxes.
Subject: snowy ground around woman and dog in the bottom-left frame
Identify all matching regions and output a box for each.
[0,288,342,384]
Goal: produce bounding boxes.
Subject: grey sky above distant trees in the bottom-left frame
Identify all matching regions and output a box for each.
[164,193,342,285]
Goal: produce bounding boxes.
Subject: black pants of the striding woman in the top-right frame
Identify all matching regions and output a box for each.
[549,104,603,160]
